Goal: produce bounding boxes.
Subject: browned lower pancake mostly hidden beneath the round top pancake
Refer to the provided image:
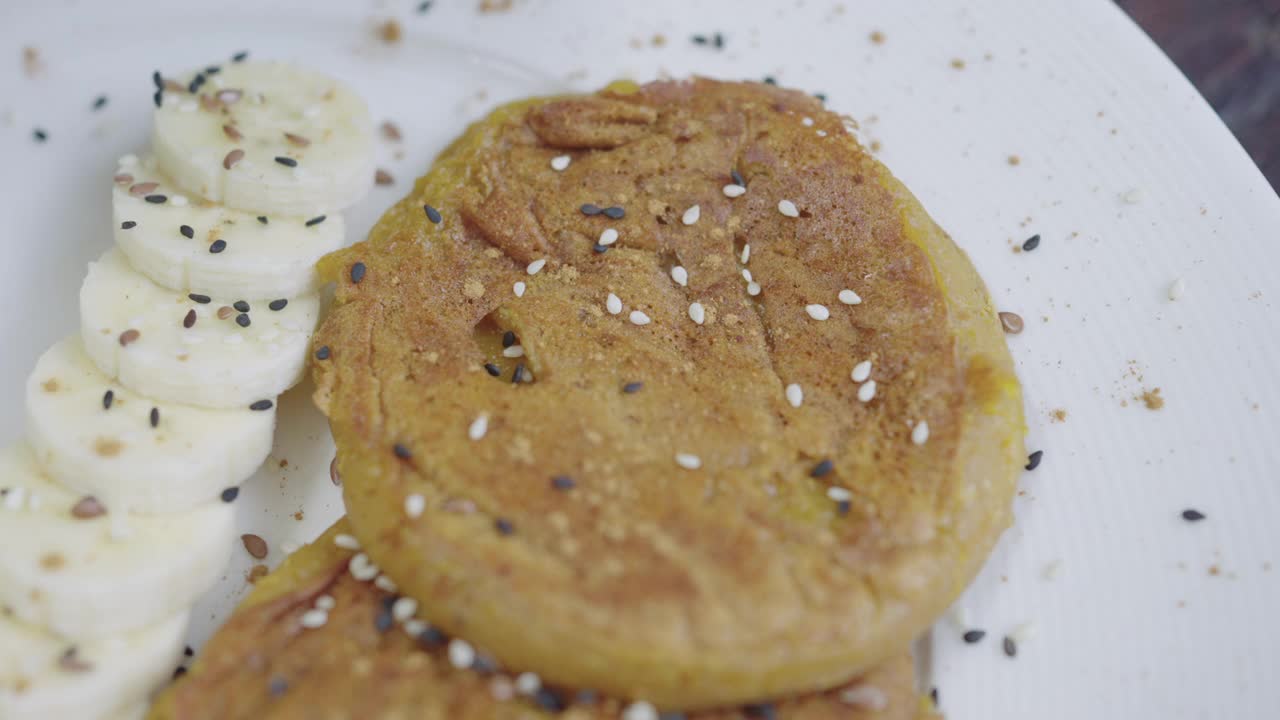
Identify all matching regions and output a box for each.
[148,520,936,720]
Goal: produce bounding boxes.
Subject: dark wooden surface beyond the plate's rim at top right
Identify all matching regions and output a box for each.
[1116,0,1280,188]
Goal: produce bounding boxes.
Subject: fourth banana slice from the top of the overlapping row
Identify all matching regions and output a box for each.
[27,336,275,512]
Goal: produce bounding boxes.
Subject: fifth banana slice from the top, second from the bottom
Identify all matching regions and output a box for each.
[0,443,236,638]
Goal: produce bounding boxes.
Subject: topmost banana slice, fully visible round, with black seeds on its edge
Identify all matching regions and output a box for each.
[152,63,374,218]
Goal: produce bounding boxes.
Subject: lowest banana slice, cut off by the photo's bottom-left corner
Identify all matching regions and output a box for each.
[0,612,187,720]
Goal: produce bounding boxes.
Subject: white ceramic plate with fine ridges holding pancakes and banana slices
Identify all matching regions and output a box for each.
[0,0,1280,720]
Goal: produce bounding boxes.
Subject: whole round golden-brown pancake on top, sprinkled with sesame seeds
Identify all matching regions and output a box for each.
[314,79,1025,708]
